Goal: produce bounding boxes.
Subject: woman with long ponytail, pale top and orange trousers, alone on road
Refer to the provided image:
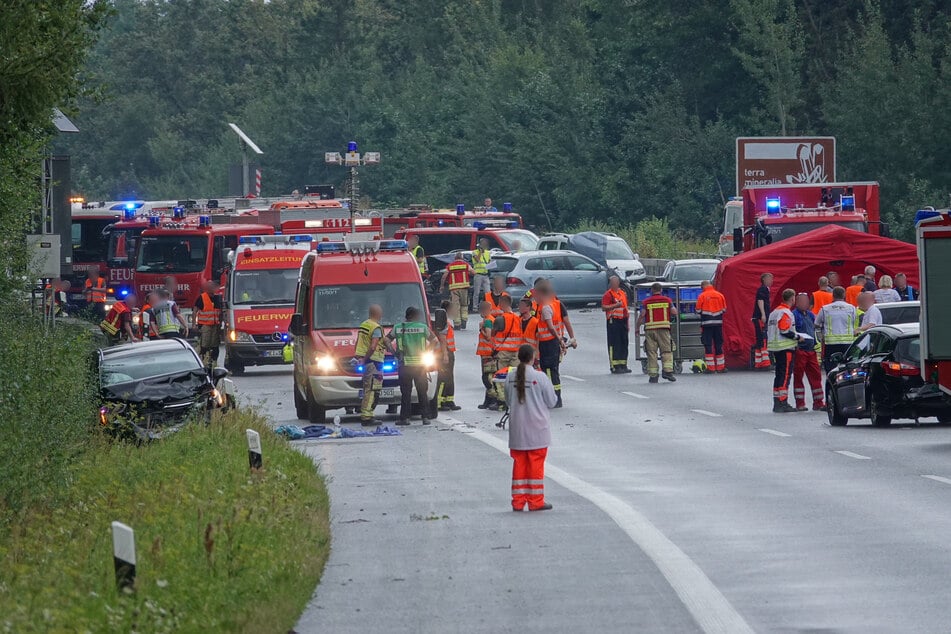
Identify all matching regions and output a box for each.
[505,344,558,511]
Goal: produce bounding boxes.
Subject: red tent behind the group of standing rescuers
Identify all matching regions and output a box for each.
[714,225,918,368]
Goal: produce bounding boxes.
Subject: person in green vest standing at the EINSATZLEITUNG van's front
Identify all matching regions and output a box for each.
[387,306,435,425]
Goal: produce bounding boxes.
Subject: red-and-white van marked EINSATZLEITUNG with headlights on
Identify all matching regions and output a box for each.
[290,239,436,424]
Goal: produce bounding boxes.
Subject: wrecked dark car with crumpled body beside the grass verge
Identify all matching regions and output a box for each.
[96,339,235,440]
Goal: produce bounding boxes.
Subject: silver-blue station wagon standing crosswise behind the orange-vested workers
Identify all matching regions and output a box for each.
[492,251,616,304]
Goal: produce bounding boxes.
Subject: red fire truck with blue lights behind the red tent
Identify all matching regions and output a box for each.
[720,182,888,255]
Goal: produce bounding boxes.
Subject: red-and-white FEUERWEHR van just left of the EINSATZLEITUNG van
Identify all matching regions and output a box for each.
[225,234,314,374]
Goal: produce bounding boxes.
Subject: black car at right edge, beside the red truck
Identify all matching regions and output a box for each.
[826,324,951,427]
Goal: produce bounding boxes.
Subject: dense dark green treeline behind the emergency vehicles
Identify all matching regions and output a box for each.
[67,0,951,242]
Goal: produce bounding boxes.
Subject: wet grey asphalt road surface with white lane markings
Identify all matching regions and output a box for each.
[229,304,951,633]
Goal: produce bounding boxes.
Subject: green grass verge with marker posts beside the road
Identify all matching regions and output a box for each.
[0,411,330,632]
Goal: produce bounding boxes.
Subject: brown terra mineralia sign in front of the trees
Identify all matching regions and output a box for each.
[736,136,835,196]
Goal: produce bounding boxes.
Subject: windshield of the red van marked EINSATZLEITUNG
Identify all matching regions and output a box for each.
[311,282,429,330]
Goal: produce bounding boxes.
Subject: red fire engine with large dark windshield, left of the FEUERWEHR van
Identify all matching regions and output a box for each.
[133,215,274,312]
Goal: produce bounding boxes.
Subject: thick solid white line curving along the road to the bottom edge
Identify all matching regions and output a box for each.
[439,417,753,634]
